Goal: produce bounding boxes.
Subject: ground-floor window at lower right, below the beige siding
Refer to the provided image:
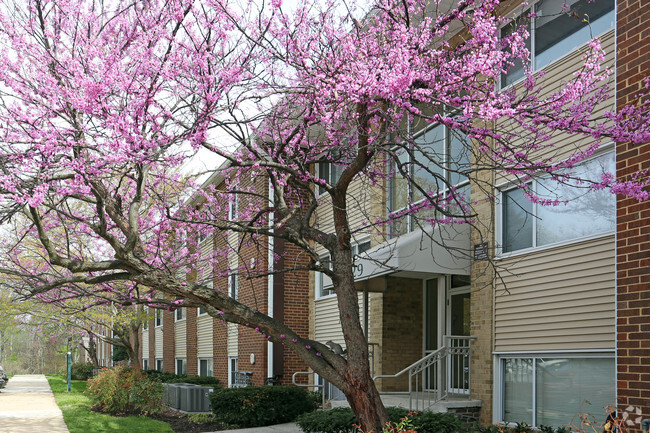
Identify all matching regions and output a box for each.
[498,354,616,427]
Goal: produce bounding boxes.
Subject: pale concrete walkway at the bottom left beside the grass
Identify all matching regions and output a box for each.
[0,374,69,433]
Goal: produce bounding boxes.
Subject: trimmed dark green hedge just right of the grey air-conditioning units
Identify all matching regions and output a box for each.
[210,386,316,427]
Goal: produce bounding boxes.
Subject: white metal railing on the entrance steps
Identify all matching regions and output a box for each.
[374,335,476,410]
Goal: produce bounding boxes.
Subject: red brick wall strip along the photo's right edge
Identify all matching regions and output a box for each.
[616,0,650,431]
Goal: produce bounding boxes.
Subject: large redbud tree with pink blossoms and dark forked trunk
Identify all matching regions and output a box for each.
[0,0,650,431]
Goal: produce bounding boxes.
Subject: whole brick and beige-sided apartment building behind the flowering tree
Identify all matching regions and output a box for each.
[142,0,650,430]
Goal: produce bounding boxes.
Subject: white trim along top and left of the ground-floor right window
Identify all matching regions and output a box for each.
[492,349,616,424]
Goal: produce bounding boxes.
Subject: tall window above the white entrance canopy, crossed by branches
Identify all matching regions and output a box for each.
[388,121,470,236]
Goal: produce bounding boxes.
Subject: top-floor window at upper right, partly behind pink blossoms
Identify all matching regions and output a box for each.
[501,0,616,87]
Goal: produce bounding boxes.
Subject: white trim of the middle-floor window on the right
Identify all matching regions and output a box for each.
[494,147,616,260]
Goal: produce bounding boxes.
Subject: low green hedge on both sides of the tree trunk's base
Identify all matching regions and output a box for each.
[296,407,468,433]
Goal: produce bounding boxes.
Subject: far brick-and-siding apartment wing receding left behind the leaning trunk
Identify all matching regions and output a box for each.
[141,163,309,387]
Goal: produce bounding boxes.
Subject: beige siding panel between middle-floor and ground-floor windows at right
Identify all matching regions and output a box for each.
[495,236,616,352]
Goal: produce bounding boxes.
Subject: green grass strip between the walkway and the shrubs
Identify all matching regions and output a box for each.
[47,375,173,433]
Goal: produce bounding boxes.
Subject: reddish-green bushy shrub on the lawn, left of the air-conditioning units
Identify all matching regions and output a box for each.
[86,366,163,414]
